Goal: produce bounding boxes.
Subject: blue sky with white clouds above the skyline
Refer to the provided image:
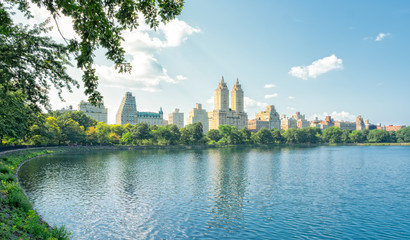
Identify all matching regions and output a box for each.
[14,0,410,125]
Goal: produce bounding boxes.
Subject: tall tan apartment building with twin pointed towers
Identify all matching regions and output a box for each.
[208,77,248,129]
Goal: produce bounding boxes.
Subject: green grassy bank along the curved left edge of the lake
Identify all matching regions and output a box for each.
[0,150,70,239]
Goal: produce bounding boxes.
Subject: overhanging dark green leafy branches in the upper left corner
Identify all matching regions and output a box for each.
[0,0,184,107]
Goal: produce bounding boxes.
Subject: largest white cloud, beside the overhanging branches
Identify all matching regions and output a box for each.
[97,19,200,92]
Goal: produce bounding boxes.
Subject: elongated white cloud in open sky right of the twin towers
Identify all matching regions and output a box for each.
[289,54,343,80]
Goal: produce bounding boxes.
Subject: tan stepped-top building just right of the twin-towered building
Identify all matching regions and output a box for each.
[248,105,281,132]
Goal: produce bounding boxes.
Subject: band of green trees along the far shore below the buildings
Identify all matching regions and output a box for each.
[0,111,410,146]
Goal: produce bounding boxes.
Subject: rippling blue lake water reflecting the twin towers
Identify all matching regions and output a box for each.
[19,146,410,239]
